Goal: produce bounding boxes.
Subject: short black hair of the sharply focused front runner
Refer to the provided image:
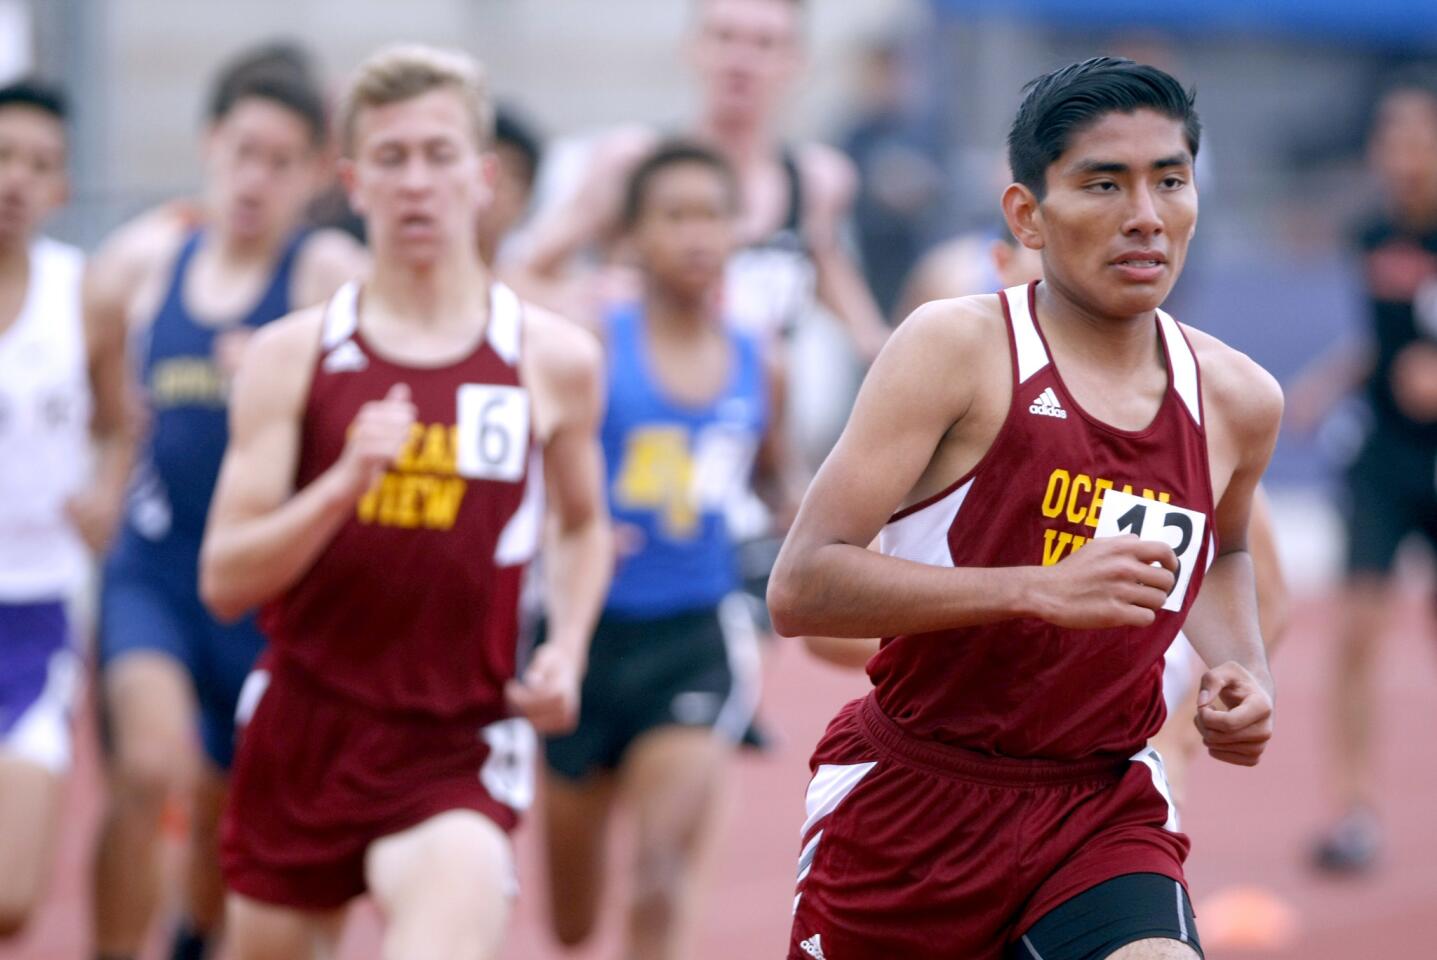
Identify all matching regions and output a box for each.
[1007,56,1203,200]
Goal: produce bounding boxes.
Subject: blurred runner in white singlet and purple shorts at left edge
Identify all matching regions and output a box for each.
[0,82,132,938]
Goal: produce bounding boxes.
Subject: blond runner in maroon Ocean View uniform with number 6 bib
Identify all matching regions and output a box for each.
[201,46,612,960]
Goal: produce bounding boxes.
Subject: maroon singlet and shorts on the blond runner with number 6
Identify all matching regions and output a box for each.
[223,286,543,910]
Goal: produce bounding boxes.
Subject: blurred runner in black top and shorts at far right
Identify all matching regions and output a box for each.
[1293,75,1437,872]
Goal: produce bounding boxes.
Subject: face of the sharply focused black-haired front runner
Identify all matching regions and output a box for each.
[1035,109,1197,318]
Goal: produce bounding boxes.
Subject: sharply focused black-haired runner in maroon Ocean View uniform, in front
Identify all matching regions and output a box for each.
[769,57,1282,960]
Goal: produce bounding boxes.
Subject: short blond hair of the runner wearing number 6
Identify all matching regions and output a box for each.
[339,43,494,155]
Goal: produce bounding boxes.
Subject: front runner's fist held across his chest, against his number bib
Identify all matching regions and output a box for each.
[1038,535,1177,629]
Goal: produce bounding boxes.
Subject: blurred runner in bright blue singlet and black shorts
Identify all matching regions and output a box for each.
[545,141,796,960]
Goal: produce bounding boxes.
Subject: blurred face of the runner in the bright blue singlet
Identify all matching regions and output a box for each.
[634,162,734,300]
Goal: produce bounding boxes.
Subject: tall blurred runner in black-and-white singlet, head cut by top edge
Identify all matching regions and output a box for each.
[527,0,887,359]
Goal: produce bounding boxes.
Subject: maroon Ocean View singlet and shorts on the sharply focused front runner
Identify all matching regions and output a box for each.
[789,283,1216,960]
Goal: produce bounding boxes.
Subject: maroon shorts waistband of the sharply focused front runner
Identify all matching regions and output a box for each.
[858,694,1131,786]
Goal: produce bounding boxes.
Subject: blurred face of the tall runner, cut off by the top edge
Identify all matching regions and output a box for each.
[691,0,800,118]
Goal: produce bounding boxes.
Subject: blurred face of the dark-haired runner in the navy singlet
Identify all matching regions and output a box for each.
[205,96,322,241]
